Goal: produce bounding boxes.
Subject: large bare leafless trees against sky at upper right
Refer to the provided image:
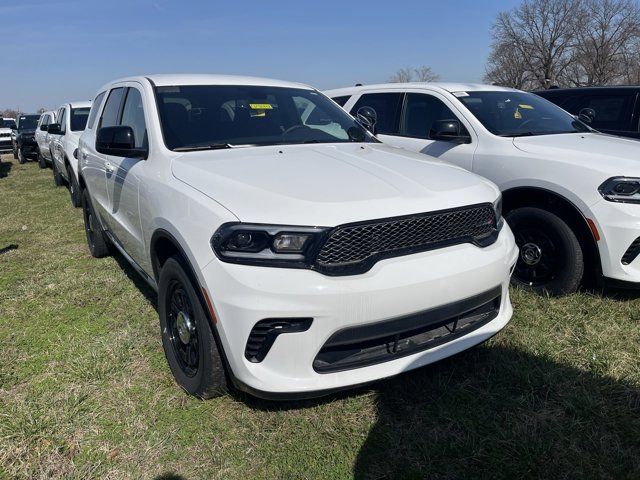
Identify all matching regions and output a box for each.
[484,0,640,90]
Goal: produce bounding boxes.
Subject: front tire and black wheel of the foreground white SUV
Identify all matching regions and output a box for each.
[158,256,227,399]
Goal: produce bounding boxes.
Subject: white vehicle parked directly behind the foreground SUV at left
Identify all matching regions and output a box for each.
[48,102,91,207]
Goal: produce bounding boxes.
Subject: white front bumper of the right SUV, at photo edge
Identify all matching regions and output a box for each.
[591,199,640,283]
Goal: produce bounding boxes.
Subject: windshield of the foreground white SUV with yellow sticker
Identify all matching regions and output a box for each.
[156,85,375,150]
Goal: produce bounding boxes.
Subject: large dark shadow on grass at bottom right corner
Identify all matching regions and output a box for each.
[354,347,640,479]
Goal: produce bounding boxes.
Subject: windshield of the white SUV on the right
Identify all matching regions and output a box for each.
[454,91,589,137]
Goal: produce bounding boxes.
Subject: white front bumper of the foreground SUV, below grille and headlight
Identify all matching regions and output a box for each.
[202,225,518,398]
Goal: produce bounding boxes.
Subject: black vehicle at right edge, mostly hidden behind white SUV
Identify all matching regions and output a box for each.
[534,86,640,138]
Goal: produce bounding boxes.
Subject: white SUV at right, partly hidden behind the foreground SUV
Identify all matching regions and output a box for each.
[327,83,640,294]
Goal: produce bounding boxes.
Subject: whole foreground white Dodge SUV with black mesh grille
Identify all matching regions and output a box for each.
[78,75,517,398]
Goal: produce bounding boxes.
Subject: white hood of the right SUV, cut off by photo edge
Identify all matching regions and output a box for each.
[513,133,640,175]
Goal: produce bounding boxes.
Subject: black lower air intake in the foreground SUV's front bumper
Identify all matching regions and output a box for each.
[313,286,502,373]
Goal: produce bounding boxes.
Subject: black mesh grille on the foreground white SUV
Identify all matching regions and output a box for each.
[316,204,496,269]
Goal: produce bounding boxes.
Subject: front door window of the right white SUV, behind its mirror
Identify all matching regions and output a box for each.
[400,93,467,139]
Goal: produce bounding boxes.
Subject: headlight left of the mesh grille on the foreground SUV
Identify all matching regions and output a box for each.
[211,223,330,268]
